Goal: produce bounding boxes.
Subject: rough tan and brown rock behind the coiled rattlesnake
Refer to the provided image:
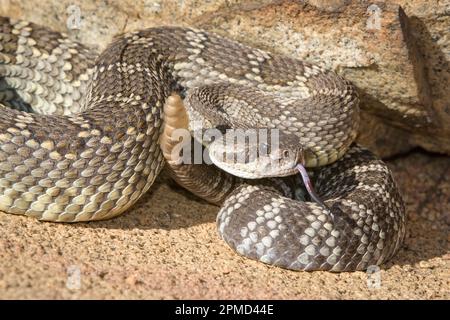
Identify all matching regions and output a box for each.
[0,0,450,156]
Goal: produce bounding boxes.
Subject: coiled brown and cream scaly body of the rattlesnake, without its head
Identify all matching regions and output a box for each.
[0,18,405,271]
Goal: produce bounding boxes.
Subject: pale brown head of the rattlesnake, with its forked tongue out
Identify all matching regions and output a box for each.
[209,128,304,179]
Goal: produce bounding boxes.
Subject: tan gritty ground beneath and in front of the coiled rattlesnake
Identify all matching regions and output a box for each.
[0,152,450,299]
